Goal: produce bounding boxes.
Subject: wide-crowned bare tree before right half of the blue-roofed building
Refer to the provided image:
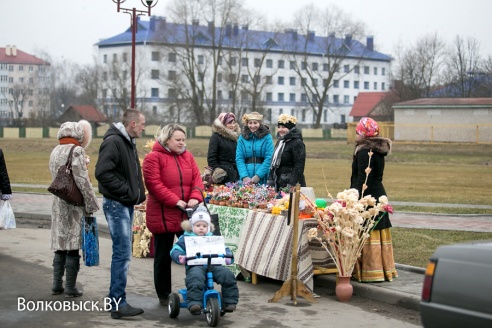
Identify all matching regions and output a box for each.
[283,5,366,128]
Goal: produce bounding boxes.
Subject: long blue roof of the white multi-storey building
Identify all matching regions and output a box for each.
[96,17,392,61]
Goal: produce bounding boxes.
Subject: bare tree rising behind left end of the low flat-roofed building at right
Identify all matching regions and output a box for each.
[395,33,445,101]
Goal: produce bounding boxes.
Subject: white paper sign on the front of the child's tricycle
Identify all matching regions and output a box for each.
[184,236,225,265]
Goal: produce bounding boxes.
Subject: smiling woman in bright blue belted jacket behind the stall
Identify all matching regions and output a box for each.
[236,112,274,184]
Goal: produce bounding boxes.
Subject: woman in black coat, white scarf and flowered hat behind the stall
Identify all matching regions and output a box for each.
[268,114,306,191]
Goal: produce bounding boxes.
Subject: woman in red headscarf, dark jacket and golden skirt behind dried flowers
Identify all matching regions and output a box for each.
[350,117,398,282]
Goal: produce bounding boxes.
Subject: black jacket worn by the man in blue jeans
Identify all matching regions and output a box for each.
[96,123,145,206]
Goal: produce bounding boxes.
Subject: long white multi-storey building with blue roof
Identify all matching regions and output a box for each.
[95,17,392,127]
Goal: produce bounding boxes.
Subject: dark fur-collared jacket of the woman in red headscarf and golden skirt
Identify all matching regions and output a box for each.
[350,137,391,230]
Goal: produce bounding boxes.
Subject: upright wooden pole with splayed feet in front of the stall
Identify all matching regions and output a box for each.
[268,184,316,305]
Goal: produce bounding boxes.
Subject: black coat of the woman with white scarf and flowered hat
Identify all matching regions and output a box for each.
[268,127,306,191]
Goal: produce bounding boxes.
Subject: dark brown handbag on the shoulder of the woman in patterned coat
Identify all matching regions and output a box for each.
[48,145,84,206]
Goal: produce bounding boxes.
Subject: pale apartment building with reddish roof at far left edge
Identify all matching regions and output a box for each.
[0,45,50,126]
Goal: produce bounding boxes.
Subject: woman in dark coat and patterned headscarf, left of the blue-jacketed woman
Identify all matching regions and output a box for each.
[207,112,241,184]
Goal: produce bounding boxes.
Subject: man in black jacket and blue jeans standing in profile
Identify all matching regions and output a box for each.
[96,109,145,319]
